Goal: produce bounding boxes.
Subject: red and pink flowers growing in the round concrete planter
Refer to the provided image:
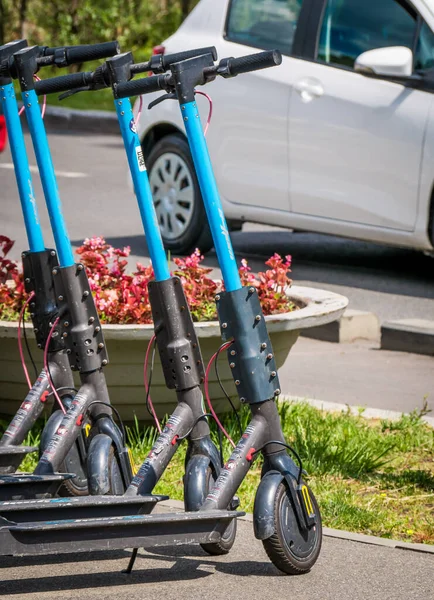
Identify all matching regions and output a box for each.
[0,236,294,324]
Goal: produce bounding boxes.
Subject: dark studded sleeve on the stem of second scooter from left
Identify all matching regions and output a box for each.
[53,264,108,373]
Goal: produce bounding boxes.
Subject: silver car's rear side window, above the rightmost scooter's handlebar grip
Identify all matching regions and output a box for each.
[226,0,303,54]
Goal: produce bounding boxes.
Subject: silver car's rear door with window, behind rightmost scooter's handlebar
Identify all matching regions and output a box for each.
[208,0,302,211]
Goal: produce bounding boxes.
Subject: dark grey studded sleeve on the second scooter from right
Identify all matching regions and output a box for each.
[148,277,205,391]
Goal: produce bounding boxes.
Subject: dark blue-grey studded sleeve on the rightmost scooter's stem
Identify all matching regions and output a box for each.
[216,286,280,404]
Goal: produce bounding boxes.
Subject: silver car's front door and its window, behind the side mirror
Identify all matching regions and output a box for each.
[289,0,432,231]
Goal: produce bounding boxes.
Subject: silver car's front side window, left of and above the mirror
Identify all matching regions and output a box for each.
[317,0,416,67]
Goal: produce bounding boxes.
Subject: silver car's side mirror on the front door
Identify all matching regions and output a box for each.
[354,46,413,78]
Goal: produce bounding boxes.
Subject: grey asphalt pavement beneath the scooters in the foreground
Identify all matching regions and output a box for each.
[0,509,434,600]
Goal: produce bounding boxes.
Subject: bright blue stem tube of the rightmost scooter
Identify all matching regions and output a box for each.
[181,102,242,292]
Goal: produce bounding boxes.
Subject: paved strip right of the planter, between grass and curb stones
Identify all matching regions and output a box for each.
[279,337,434,418]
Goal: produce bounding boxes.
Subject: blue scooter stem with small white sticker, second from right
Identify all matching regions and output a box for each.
[115,98,170,281]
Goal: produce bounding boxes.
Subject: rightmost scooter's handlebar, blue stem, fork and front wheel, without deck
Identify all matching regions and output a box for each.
[101,51,322,574]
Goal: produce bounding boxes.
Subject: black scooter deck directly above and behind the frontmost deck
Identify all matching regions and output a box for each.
[0,495,168,523]
